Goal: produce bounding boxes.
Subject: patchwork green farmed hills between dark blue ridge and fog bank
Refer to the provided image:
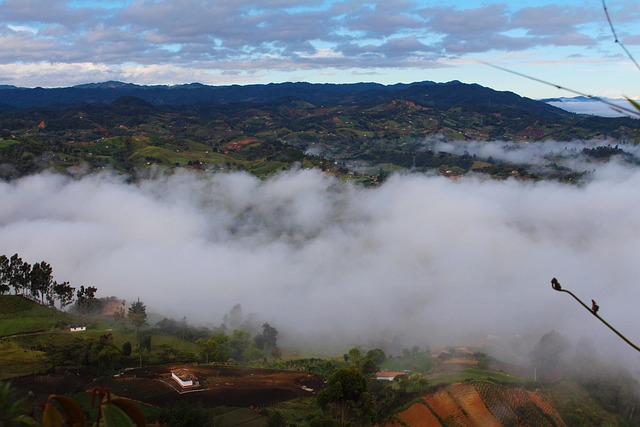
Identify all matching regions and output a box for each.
[0,94,638,183]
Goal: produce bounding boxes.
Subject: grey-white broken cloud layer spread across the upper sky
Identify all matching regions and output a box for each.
[0,0,640,92]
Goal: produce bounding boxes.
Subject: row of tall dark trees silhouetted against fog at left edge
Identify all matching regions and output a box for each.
[0,253,98,311]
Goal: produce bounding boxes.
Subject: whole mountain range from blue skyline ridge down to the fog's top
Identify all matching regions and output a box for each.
[0,81,638,179]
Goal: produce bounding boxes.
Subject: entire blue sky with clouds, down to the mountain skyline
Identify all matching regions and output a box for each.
[0,0,640,98]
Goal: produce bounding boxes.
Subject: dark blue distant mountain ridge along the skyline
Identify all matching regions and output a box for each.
[0,80,568,117]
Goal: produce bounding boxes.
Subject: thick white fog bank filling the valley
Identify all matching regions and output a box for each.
[0,142,640,368]
